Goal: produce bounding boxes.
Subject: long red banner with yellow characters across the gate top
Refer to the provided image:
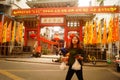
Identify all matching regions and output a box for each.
[12,6,119,15]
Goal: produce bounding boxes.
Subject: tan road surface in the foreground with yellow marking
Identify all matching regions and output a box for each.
[0,60,120,80]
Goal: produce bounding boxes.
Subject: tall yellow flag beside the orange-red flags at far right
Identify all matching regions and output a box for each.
[107,17,113,43]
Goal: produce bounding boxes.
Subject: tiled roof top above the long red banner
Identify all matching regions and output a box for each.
[26,0,78,8]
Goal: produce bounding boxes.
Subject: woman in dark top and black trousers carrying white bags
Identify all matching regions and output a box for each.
[63,36,84,80]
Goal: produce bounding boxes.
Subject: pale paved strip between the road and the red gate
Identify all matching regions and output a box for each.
[4,55,109,67]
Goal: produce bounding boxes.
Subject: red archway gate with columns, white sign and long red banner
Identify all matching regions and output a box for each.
[12,6,120,59]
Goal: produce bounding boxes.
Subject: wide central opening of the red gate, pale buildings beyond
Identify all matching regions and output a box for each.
[40,26,64,54]
